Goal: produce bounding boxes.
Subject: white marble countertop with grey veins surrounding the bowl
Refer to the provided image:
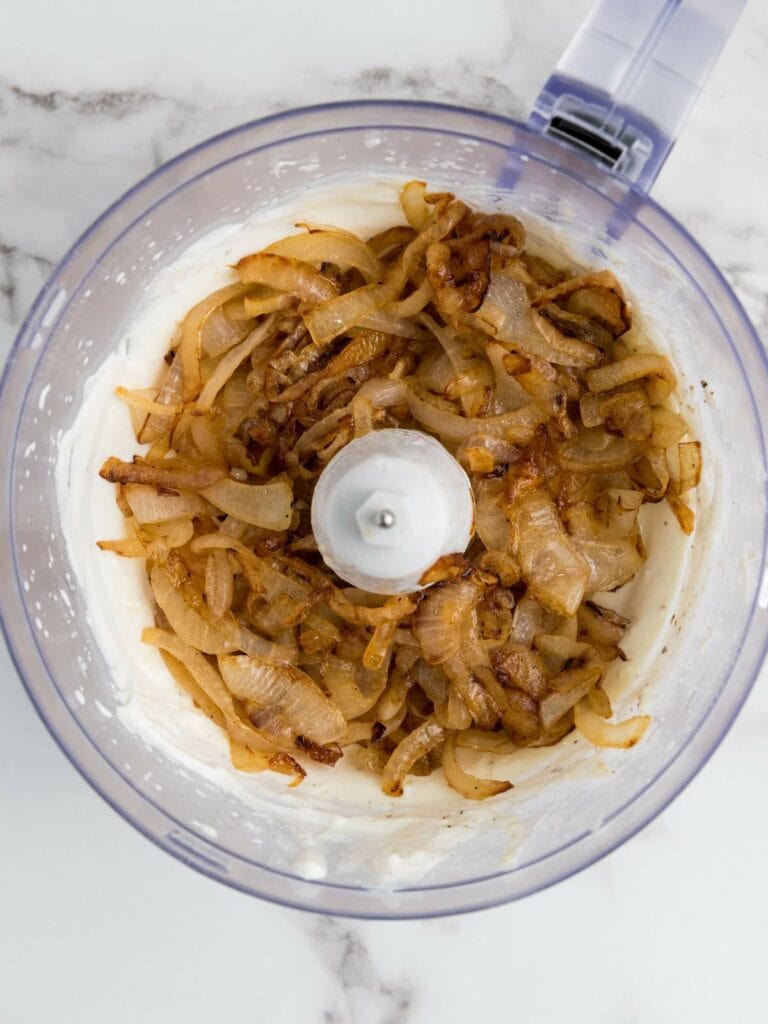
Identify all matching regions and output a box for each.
[0,0,768,1024]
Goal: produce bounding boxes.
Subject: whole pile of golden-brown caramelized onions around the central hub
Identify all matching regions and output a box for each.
[99,181,701,800]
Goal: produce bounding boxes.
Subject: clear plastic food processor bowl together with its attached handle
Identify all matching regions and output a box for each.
[0,0,768,918]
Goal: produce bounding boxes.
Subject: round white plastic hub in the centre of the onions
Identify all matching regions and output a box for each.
[312,430,474,594]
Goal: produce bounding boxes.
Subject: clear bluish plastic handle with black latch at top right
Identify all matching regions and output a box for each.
[528,0,746,193]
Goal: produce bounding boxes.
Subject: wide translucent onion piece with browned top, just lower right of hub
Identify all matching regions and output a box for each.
[509,490,590,615]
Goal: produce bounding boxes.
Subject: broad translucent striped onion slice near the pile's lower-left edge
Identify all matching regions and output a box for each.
[219,654,346,743]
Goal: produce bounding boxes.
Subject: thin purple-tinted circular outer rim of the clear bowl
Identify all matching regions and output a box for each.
[0,99,768,919]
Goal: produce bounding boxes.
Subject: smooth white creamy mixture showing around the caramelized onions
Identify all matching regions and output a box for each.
[56,180,690,886]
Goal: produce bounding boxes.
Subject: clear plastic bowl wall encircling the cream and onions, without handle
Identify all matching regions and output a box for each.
[0,102,768,918]
